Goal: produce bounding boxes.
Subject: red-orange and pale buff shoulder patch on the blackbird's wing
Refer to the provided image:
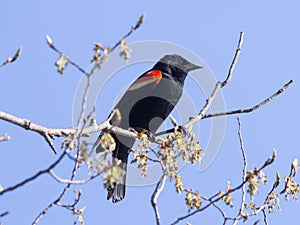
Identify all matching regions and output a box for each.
[128,70,162,91]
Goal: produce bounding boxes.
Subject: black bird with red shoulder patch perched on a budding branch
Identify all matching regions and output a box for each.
[96,55,201,202]
